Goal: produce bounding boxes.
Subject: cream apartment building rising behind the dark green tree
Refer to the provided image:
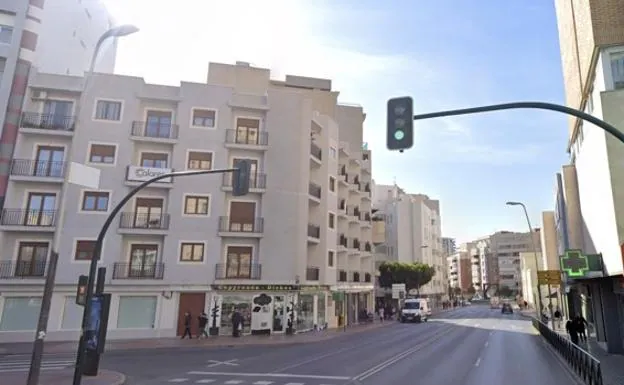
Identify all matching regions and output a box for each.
[373,185,448,299]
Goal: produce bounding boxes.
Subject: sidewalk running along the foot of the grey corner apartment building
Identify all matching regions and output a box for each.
[0,321,395,354]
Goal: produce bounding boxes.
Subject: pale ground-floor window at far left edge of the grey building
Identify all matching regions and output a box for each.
[0,297,41,331]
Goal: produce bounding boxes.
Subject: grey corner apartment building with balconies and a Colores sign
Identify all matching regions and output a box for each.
[0,63,374,341]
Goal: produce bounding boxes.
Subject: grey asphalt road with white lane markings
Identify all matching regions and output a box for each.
[0,306,575,385]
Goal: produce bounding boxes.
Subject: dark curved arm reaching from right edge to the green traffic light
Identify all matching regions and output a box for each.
[414,102,624,143]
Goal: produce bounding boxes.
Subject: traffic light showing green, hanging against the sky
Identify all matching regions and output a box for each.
[386,96,414,151]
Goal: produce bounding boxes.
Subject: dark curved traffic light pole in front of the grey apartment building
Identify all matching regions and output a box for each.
[72,165,239,385]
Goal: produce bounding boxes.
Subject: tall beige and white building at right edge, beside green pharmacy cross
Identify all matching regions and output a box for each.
[555,0,624,353]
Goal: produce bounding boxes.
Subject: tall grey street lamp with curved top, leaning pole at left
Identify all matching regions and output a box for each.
[27,25,139,385]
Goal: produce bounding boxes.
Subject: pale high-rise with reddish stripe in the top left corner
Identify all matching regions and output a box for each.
[0,0,117,205]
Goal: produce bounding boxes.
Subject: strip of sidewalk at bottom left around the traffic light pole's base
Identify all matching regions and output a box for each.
[2,369,126,385]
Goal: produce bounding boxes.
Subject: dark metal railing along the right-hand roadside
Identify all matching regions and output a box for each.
[531,317,603,385]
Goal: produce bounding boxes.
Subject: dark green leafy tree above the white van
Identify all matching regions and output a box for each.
[379,262,435,292]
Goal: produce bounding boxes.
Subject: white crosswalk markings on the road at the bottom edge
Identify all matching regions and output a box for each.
[166,371,350,385]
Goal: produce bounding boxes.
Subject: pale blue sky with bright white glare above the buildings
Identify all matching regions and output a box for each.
[104,0,568,242]
